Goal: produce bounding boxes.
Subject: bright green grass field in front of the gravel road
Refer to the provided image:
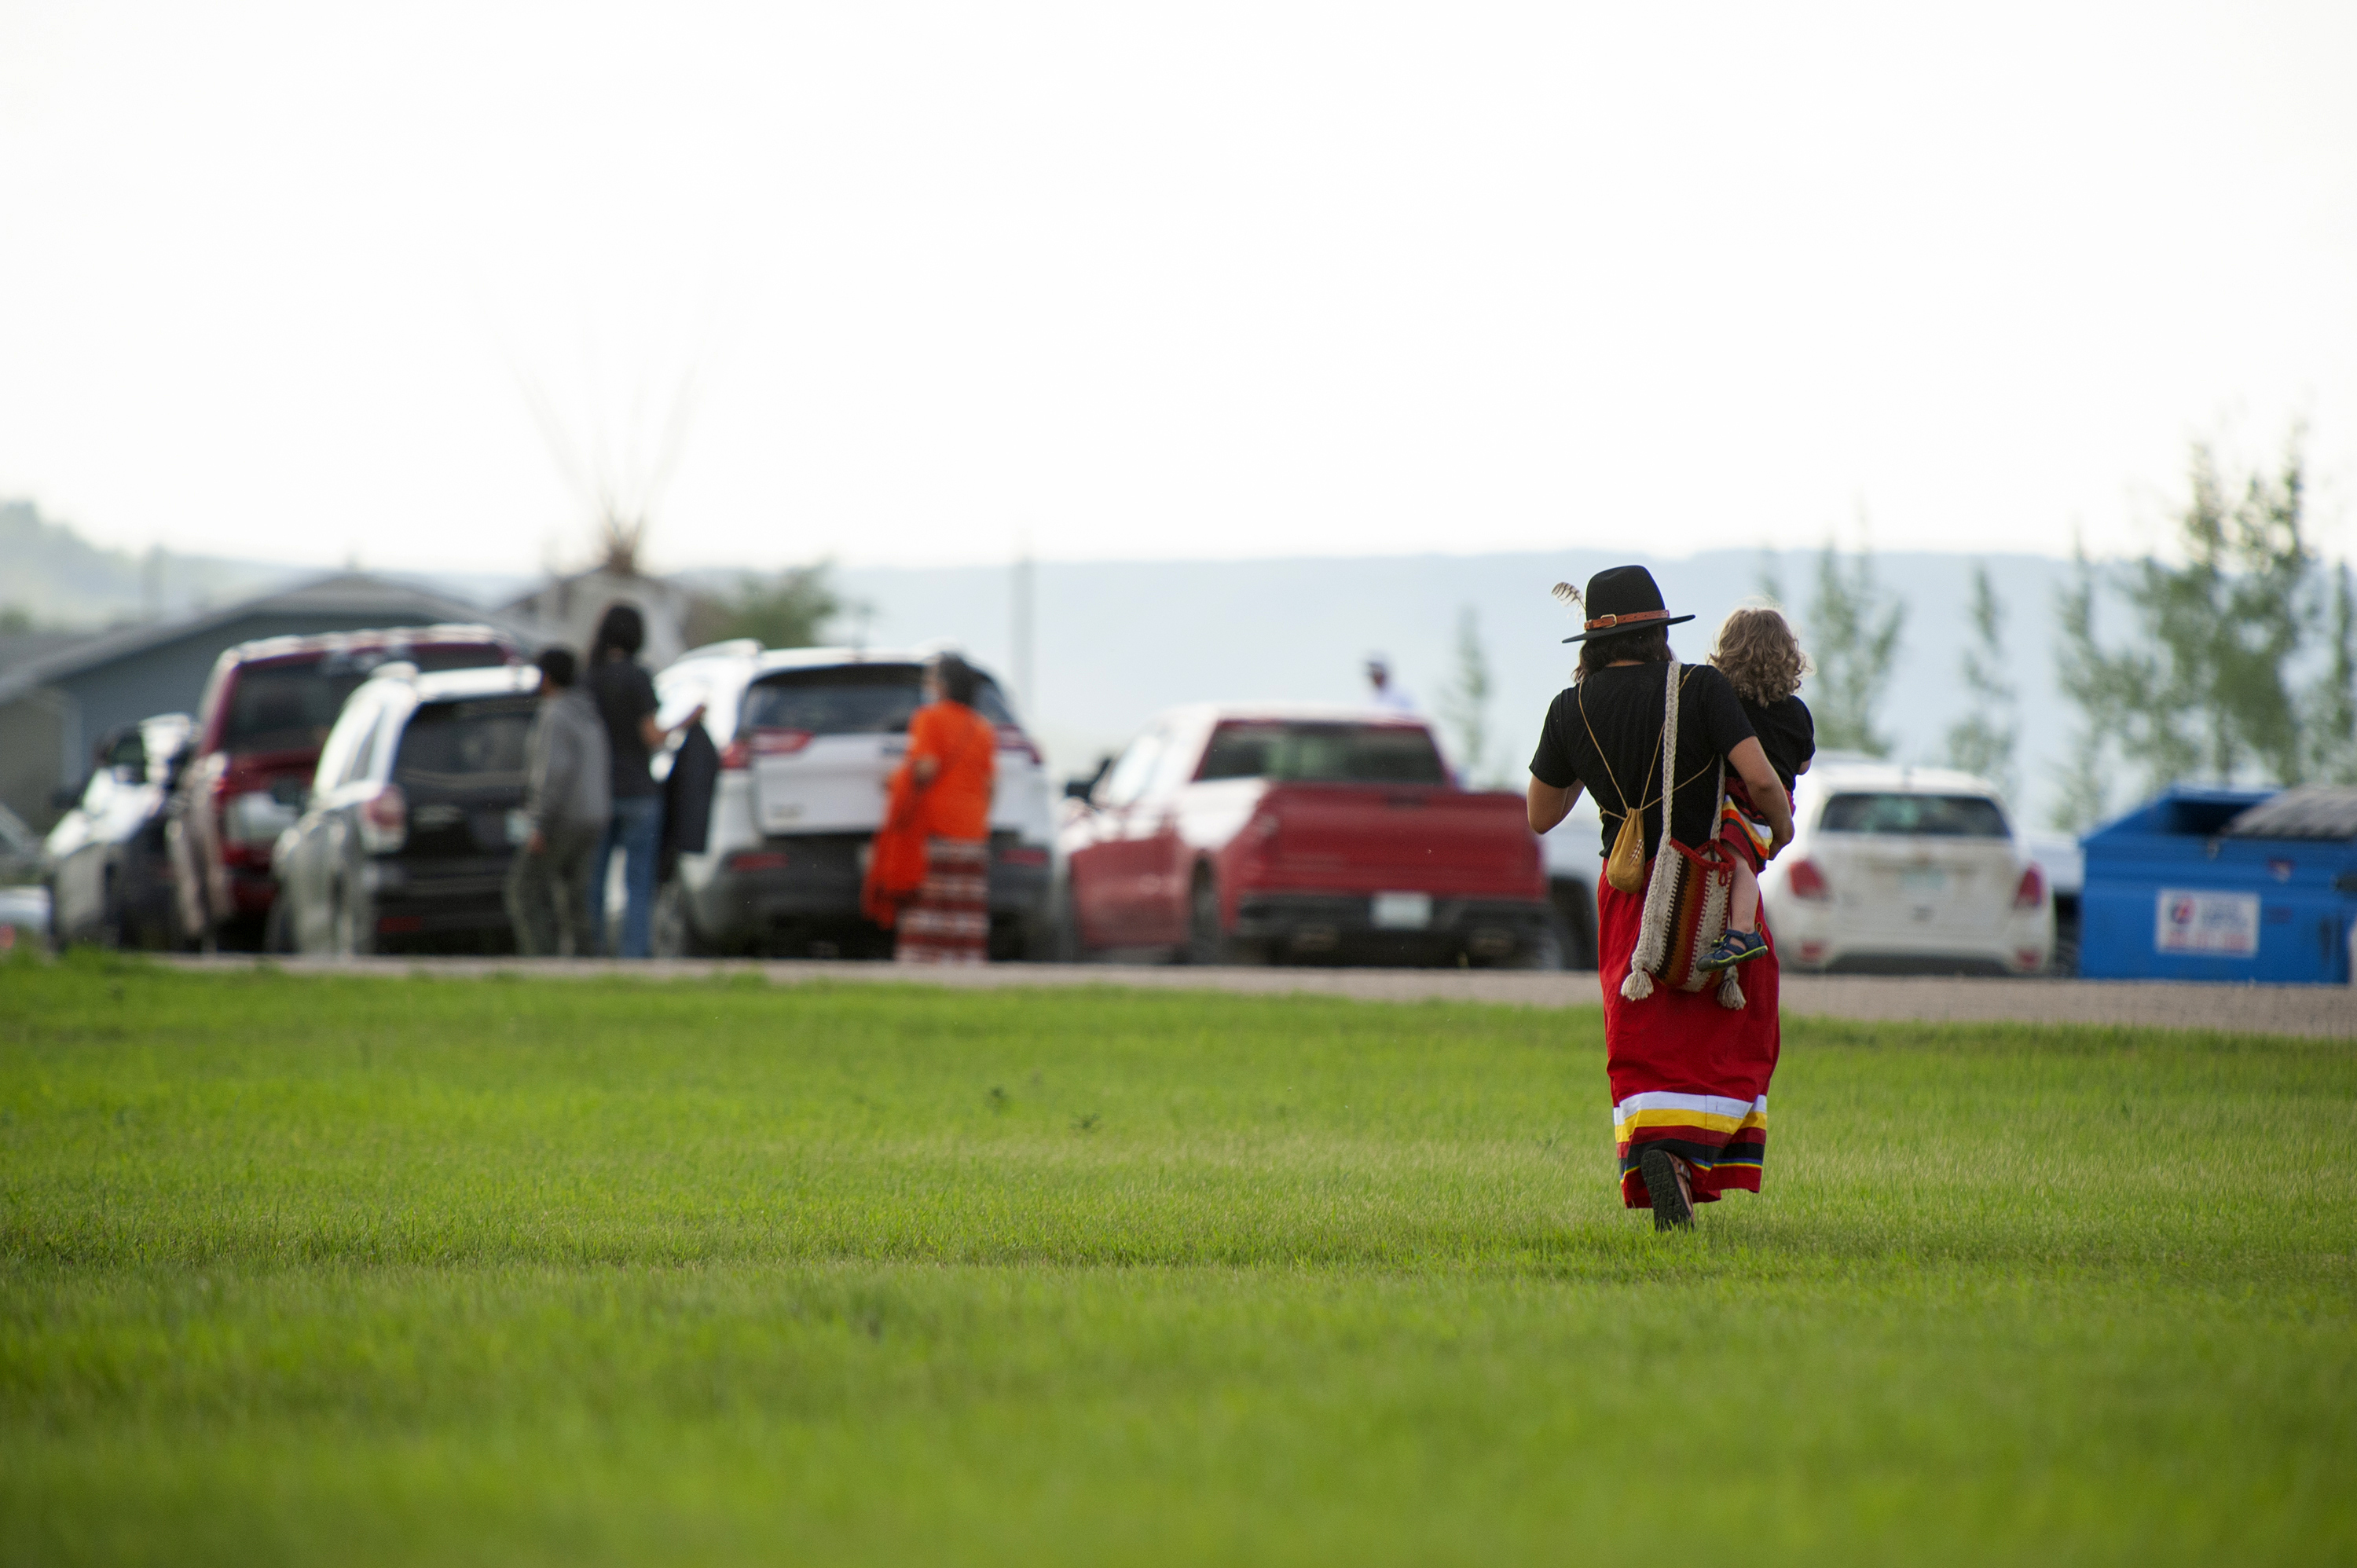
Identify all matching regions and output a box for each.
[0,960,2357,1566]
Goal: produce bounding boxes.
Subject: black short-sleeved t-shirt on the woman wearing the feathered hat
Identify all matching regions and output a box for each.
[1530,665,1751,856]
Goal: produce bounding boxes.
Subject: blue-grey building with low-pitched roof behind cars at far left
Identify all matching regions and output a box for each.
[0,573,542,833]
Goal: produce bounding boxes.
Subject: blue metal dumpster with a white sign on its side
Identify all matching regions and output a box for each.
[2079,786,2357,986]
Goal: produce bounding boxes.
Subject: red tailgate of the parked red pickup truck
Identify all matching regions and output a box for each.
[1249,782,1546,899]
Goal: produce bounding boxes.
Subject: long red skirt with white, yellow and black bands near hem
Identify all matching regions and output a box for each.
[1596,877,1782,1210]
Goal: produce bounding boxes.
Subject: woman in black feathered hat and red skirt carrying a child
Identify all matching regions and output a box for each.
[1530,566,1791,1231]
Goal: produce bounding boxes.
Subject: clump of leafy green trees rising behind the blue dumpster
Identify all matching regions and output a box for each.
[2058,438,2350,828]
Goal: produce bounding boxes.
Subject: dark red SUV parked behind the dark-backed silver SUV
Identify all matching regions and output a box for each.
[165,625,523,948]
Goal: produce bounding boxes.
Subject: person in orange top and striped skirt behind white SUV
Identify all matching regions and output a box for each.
[860,653,999,965]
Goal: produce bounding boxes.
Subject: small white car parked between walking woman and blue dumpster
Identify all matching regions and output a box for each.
[1761,757,2055,974]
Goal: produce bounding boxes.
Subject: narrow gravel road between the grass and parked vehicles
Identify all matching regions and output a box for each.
[160,955,2357,1040]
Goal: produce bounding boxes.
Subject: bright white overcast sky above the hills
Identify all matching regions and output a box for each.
[0,0,2357,570]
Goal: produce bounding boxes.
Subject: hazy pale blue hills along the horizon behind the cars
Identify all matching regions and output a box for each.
[0,502,2126,826]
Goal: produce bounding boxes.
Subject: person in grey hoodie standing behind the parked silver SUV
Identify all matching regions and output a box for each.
[507,648,613,958]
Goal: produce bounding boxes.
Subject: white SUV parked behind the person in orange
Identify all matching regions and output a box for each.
[655,639,1056,960]
